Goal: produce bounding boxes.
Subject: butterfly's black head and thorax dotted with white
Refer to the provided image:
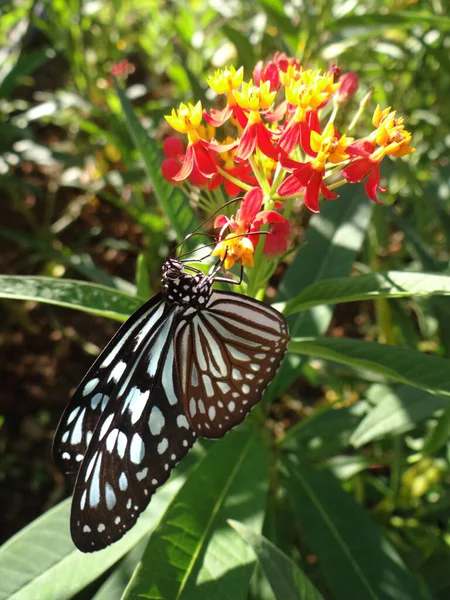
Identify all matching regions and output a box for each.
[162,258,212,310]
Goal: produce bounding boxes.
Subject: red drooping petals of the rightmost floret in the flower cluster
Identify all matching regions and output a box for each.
[342,139,386,204]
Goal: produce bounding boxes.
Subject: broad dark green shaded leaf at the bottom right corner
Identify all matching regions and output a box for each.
[287,459,421,600]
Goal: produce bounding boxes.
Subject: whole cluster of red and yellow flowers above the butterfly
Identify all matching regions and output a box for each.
[162,53,414,269]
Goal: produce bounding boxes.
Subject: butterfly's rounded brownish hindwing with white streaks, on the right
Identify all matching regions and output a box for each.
[176,292,289,438]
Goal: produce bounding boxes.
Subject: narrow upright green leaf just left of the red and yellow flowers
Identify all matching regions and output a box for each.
[116,85,198,242]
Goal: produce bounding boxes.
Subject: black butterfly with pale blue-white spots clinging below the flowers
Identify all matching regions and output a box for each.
[53,259,289,552]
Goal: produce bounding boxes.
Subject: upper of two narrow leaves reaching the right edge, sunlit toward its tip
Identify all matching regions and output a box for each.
[275,271,450,316]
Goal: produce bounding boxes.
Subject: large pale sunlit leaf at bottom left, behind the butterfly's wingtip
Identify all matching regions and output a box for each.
[0,446,202,600]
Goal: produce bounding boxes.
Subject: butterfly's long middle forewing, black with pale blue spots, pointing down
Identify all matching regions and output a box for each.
[71,309,196,552]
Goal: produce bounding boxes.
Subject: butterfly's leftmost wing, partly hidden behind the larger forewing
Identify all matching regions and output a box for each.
[53,294,165,473]
